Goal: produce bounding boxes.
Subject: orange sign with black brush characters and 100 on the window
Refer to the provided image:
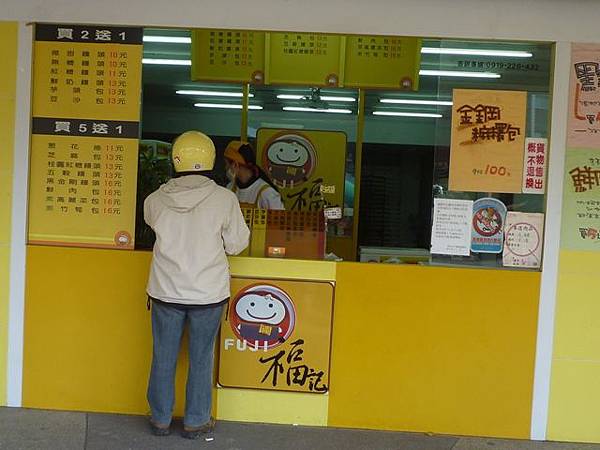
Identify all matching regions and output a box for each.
[449,89,527,193]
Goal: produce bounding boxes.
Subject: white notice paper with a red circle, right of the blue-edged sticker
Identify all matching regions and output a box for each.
[502,211,544,268]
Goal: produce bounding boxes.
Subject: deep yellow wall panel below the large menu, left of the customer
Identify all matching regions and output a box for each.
[23,246,188,415]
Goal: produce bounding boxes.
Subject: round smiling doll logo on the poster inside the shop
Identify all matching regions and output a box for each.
[263,131,317,188]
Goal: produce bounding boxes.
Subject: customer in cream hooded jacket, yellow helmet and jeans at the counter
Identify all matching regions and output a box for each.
[144,131,250,439]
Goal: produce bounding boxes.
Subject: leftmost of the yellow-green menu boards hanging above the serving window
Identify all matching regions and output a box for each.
[192,30,265,84]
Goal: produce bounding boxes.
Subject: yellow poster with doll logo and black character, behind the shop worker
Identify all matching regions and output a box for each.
[257,128,346,211]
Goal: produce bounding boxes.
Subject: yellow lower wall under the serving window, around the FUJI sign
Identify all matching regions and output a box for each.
[23,246,539,438]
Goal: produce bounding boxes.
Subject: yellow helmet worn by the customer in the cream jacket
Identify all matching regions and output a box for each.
[171,131,216,172]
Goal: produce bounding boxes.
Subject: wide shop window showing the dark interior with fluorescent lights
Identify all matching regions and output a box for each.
[136,29,552,267]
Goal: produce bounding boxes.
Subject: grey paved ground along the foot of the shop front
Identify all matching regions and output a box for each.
[0,408,600,450]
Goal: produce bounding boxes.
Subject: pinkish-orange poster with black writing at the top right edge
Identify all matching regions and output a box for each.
[567,44,600,149]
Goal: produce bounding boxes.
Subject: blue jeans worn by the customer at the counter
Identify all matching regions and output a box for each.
[148,301,224,427]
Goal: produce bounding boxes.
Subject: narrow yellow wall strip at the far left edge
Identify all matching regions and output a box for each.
[0,22,18,405]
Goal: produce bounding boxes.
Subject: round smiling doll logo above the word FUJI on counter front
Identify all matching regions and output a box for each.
[229,284,296,350]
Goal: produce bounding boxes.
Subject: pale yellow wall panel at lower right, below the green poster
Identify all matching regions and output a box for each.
[548,251,600,442]
